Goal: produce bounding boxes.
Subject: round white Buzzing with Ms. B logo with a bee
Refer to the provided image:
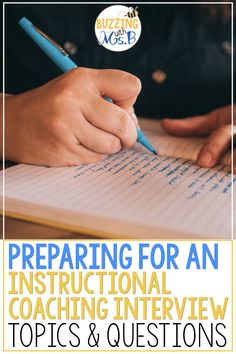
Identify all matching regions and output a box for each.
[95,5,141,52]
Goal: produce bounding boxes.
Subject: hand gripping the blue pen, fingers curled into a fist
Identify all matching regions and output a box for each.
[5,68,141,166]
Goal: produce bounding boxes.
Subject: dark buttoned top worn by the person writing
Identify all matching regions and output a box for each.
[5,4,236,118]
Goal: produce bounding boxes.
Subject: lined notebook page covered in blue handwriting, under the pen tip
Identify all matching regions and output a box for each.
[2,144,236,238]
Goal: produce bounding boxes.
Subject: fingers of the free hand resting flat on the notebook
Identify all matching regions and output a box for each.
[162,106,236,170]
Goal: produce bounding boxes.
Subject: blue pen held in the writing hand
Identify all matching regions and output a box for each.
[19,17,157,154]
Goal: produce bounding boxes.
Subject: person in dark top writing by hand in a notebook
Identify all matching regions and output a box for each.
[1,4,232,167]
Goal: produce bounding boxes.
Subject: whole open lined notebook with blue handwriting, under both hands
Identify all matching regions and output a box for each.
[1,121,236,239]
